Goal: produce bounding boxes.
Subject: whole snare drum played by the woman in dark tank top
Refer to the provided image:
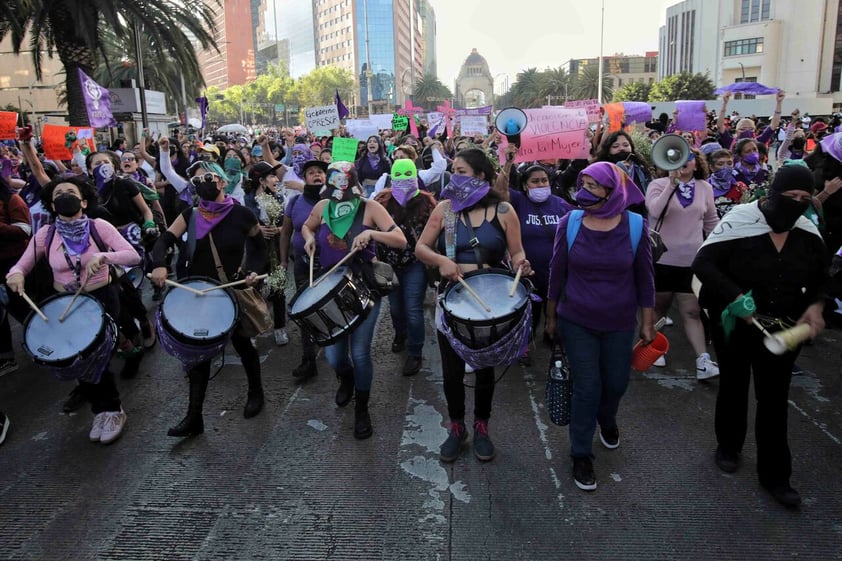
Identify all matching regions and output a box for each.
[441,269,530,349]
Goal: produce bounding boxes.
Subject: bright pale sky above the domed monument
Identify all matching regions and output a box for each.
[429,0,680,91]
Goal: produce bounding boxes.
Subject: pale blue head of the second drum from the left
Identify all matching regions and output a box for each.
[161,279,237,341]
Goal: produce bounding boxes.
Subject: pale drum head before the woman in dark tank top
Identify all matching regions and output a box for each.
[443,271,529,321]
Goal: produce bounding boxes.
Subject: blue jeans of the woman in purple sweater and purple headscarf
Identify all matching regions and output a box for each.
[556,318,635,458]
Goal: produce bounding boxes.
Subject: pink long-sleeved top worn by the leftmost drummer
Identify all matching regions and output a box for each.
[6,218,140,285]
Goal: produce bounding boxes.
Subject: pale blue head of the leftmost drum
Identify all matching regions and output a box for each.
[24,294,105,364]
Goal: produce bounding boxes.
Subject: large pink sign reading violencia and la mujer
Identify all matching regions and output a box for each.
[498,106,590,162]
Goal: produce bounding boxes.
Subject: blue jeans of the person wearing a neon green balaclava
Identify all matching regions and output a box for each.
[389,261,427,357]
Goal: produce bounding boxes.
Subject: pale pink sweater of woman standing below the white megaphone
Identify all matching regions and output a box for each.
[646,177,719,267]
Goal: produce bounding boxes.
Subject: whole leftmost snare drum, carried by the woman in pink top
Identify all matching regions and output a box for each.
[23,293,117,384]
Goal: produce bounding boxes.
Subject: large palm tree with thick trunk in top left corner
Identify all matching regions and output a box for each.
[0,0,218,125]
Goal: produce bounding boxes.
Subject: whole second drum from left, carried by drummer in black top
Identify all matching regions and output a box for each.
[155,277,238,370]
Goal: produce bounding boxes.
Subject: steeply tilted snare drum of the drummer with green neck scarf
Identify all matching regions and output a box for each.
[289,267,374,347]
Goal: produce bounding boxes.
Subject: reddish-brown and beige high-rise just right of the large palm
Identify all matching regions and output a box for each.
[198,0,256,88]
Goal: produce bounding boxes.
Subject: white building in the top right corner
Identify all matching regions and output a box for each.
[658,0,842,112]
